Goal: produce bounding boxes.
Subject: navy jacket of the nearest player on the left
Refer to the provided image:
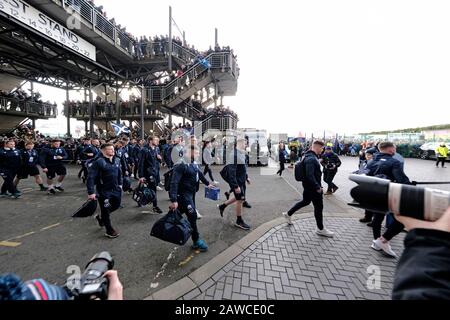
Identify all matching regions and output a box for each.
[86,155,123,197]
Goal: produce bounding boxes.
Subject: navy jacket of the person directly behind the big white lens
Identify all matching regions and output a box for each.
[367,153,411,184]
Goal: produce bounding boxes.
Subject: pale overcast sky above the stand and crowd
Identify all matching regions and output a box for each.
[37,0,450,135]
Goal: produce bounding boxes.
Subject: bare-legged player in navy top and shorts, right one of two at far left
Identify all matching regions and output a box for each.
[40,140,69,194]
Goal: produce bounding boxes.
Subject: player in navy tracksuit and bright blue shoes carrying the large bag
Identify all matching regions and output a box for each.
[169,145,213,252]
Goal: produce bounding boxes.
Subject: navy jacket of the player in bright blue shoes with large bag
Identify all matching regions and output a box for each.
[169,163,210,202]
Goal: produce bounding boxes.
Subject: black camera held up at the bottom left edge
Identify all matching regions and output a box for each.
[71,251,114,300]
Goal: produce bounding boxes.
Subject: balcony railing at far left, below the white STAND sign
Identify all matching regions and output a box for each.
[0,97,58,118]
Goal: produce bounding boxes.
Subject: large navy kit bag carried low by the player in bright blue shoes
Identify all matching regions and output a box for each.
[150,210,192,246]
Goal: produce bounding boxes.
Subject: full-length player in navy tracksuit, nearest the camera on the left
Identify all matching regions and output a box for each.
[86,144,123,238]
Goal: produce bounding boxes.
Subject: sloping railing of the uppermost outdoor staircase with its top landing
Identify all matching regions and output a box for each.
[147,52,238,101]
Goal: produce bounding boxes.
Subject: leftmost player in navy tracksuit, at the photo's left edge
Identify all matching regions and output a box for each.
[0,140,22,199]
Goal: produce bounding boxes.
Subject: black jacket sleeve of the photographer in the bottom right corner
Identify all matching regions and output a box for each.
[392,229,450,300]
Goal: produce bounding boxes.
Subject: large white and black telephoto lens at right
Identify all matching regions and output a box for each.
[349,174,450,221]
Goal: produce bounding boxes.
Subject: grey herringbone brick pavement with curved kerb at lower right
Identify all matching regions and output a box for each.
[181,215,404,300]
